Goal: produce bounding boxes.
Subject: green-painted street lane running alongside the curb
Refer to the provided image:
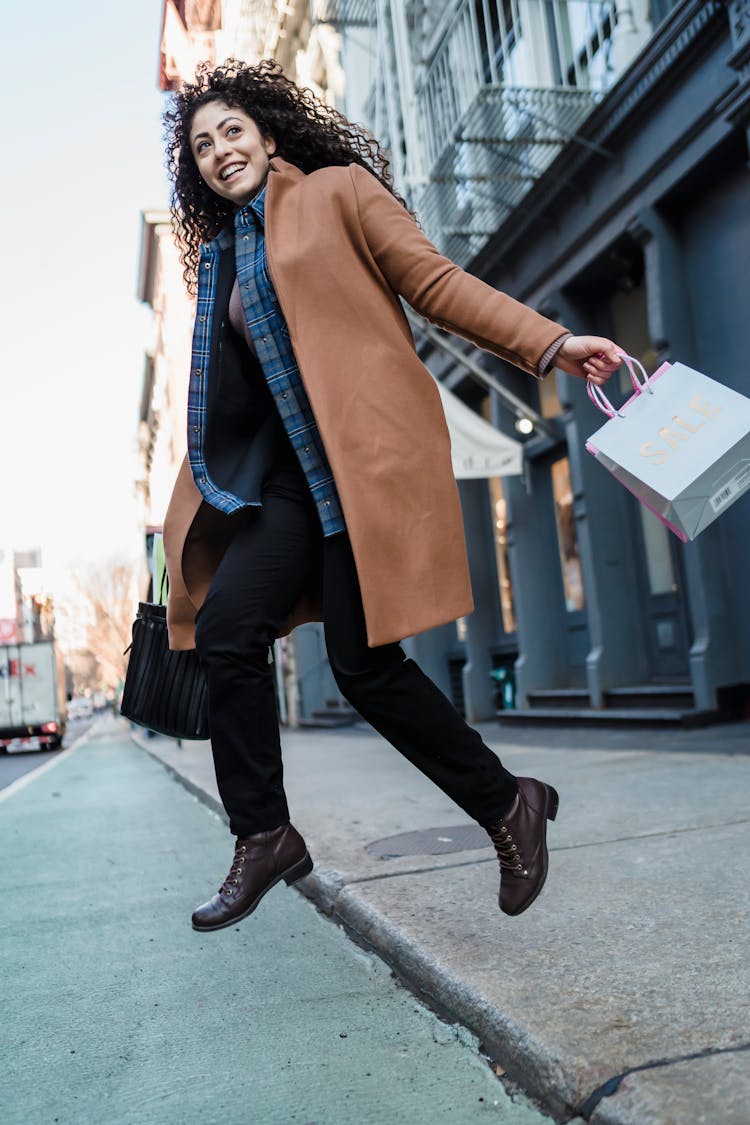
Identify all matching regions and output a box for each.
[0,717,557,1125]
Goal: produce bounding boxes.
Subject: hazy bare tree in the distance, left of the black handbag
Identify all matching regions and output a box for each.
[61,559,144,692]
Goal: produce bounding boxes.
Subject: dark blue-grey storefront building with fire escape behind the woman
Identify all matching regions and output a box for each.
[314,0,750,721]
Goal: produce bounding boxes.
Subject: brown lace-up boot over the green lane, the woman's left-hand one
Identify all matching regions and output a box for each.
[192,825,313,930]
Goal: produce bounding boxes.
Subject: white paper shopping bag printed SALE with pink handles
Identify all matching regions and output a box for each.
[586,356,750,542]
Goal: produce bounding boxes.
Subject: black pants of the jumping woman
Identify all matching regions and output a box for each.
[196,470,517,836]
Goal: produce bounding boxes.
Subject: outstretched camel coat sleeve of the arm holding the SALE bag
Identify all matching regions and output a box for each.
[350,164,568,377]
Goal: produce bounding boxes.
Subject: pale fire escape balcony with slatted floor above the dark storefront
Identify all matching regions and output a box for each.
[413,0,620,264]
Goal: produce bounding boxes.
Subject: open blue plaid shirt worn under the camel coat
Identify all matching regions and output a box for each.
[188,186,346,536]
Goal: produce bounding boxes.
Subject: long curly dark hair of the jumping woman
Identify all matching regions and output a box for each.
[164,59,406,291]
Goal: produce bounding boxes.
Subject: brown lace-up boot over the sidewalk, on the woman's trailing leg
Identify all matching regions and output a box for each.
[487,777,560,915]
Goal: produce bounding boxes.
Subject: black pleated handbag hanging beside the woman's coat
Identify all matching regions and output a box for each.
[120,585,209,739]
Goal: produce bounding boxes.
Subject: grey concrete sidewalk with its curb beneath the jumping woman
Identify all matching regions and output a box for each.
[135,722,750,1125]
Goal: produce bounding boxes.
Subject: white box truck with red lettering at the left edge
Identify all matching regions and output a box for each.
[0,640,66,754]
